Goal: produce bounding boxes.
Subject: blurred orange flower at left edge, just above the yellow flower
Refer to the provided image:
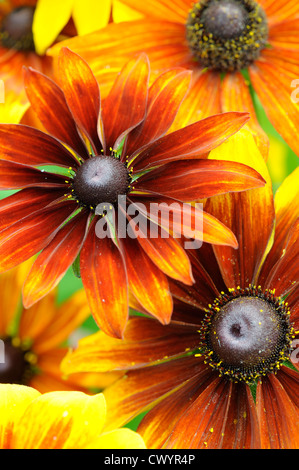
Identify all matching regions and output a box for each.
[0,261,119,393]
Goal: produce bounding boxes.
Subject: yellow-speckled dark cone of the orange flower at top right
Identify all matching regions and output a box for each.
[186,0,268,72]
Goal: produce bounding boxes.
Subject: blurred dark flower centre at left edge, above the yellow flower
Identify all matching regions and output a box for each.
[0,338,29,384]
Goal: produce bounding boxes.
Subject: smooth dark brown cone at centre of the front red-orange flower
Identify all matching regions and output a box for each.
[73,155,130,208]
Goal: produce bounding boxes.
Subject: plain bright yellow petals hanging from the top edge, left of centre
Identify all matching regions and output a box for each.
[32,0,111,55]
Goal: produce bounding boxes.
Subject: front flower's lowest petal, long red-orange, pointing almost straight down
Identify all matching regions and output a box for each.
[80,218,128,338]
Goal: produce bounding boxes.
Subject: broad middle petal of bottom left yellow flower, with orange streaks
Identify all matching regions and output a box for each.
[12,391,106,449]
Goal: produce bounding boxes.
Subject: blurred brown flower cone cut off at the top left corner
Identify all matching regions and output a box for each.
[0,6,35,51]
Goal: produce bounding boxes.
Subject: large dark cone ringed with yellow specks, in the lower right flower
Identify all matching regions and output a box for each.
[202,289,293,382]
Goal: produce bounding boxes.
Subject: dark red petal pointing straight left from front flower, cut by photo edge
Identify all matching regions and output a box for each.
[0,160,66,190]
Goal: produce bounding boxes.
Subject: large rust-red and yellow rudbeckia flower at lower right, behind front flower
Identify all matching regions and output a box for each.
[62,135,299,449]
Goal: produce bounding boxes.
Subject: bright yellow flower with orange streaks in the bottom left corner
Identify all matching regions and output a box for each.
[0,384,145,449]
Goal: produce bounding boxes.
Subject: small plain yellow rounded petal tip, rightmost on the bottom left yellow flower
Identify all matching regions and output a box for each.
[86,428,146,449]
